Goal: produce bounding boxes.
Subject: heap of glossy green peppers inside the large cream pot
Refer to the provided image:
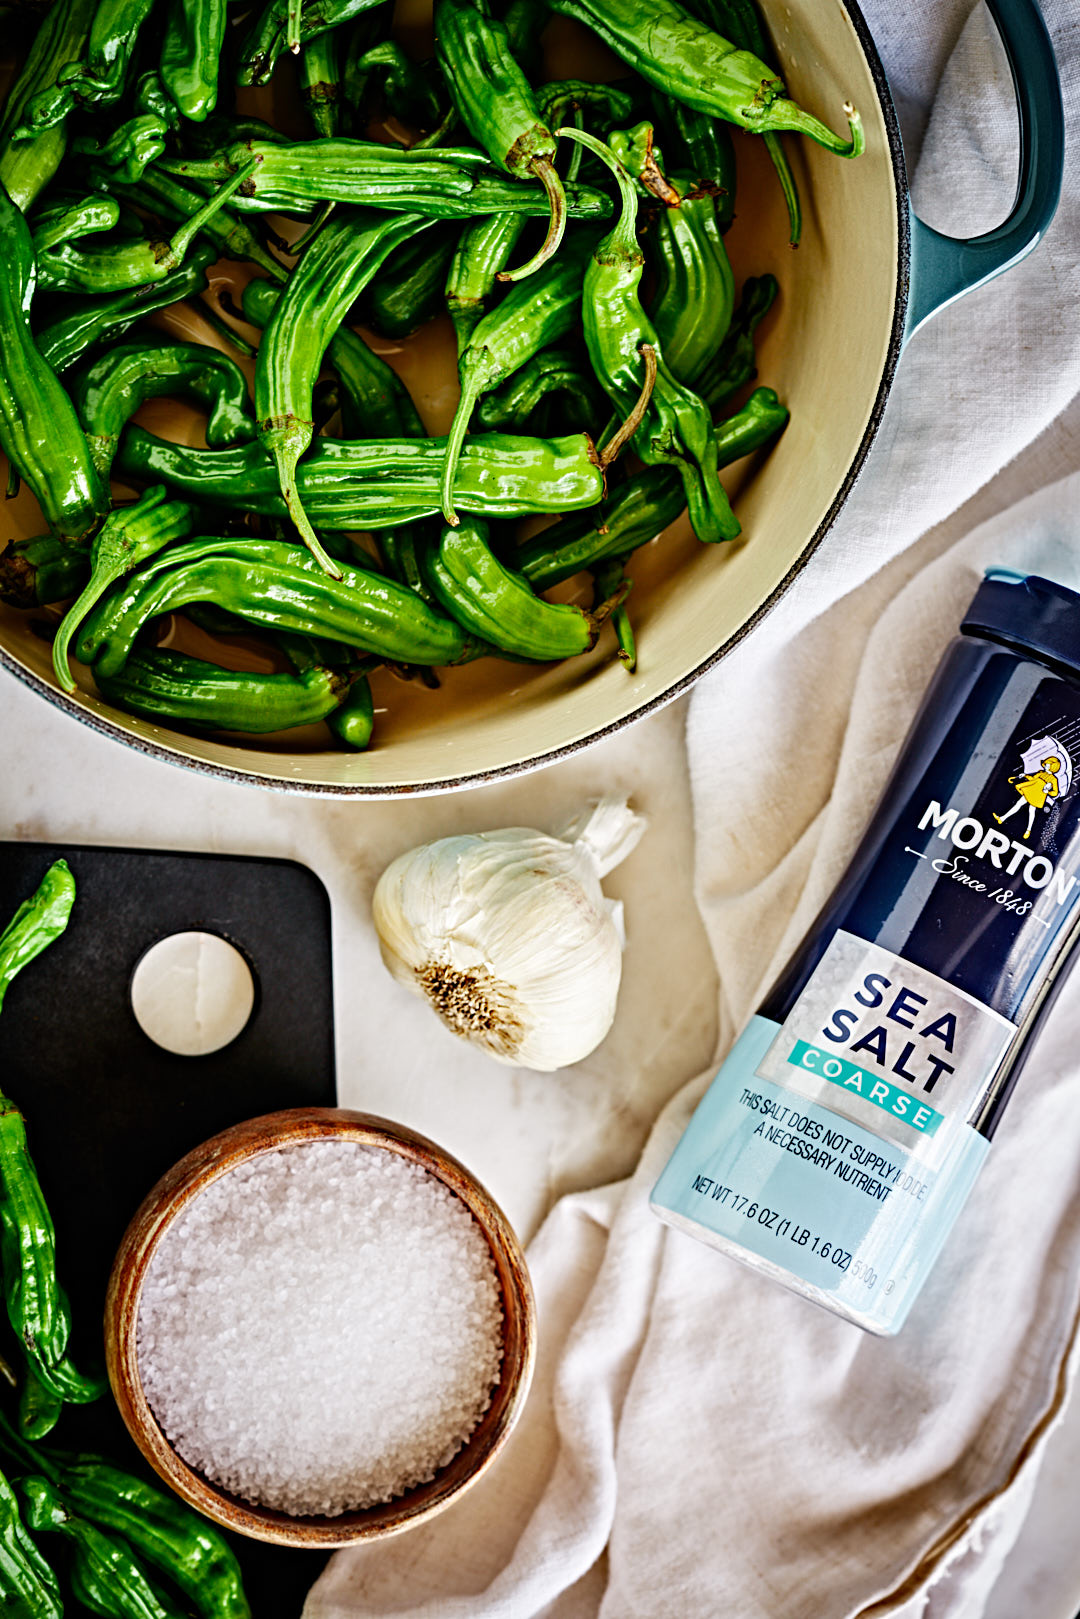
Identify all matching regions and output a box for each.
[0,0,863,744]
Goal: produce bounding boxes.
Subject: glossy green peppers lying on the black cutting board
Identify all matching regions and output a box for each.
[0,860,251,1619]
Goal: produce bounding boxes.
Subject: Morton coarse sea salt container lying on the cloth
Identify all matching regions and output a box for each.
[653,572,1080,1334]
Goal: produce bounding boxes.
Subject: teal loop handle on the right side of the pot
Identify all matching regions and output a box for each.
[904,0,1065,342]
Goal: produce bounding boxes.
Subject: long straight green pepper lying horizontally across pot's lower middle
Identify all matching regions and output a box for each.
[115,427,604,529]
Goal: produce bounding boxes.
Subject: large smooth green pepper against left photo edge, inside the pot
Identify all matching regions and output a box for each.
[0,178,108,539]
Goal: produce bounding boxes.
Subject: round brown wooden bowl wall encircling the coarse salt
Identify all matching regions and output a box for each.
[105,1107,536,1548]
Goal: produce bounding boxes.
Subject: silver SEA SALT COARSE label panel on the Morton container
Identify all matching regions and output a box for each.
[756,931,1015,1161]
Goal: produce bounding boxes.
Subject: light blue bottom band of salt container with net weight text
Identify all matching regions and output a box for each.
[653,1017,988,1332]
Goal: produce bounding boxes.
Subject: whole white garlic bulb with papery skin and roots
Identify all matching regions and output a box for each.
[372,798,646,1073]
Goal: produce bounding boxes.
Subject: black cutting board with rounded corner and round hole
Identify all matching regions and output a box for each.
[0,842,337,1619]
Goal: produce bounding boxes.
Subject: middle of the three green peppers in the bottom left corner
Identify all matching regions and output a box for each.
[18,1475,183,1619]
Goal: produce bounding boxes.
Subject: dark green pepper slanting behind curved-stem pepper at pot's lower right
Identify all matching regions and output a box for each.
[515,389,789,591]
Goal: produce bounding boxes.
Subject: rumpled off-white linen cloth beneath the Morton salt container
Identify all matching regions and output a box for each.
[304,0,1080,1619]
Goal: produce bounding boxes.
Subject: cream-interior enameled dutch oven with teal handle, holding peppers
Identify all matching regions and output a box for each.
[0,0,1064,797]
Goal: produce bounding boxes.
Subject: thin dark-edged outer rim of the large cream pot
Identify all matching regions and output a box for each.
[0,0,912,800]
